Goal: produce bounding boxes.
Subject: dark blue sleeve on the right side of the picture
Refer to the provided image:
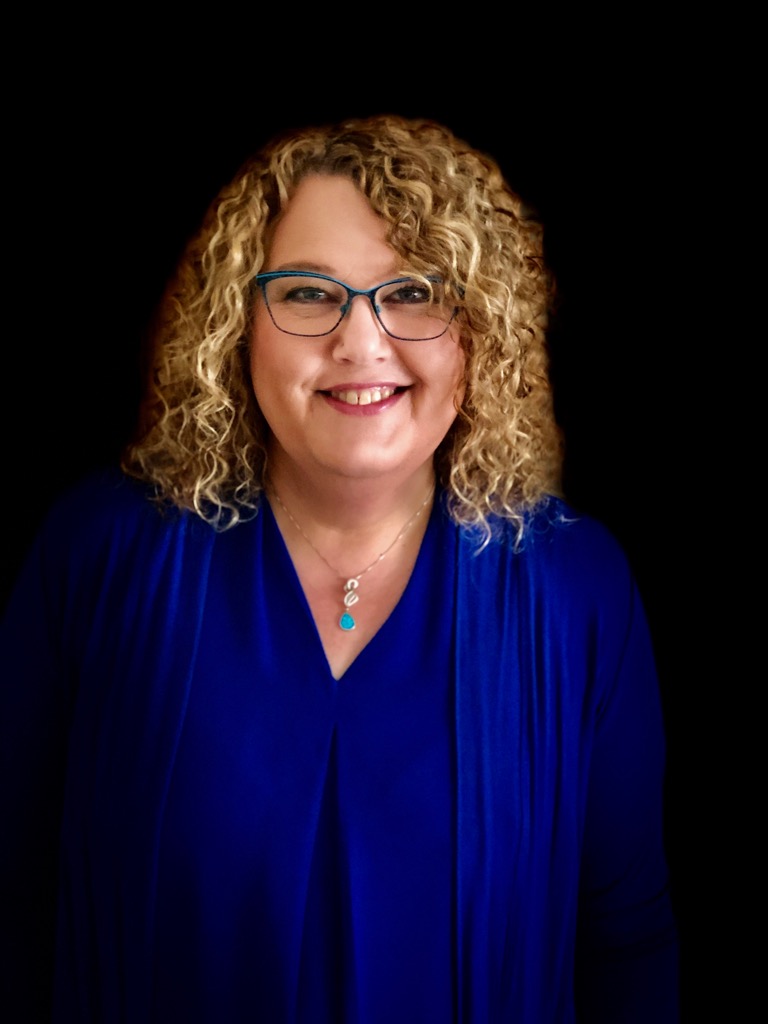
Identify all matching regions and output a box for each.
[575,581,679,1024]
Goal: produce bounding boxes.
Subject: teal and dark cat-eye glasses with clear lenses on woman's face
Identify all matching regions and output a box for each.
[254,270,459,341]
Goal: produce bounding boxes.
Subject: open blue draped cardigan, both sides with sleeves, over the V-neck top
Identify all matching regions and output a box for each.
[0,476,678,1024]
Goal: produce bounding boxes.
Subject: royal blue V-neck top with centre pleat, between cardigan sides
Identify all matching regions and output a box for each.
[153,491,455,1024]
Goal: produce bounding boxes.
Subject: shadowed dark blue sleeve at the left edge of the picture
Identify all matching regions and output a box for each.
[0,536,76,1020]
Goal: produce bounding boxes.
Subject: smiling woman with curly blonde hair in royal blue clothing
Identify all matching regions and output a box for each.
[3,117,677,1024]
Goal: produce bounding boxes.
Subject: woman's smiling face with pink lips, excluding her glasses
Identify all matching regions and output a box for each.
[251,175,464,482]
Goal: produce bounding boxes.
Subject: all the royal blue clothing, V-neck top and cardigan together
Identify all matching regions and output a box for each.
[0,478,677,1024]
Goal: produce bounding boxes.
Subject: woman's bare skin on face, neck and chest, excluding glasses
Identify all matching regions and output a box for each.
[250,175,465,678]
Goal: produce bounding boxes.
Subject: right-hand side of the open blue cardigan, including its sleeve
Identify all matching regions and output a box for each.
[456,516,678,1024]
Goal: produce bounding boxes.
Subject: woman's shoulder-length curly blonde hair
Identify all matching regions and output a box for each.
[122,116,561,540]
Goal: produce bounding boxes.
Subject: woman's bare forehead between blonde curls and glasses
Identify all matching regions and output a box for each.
[268,174,398,285]
